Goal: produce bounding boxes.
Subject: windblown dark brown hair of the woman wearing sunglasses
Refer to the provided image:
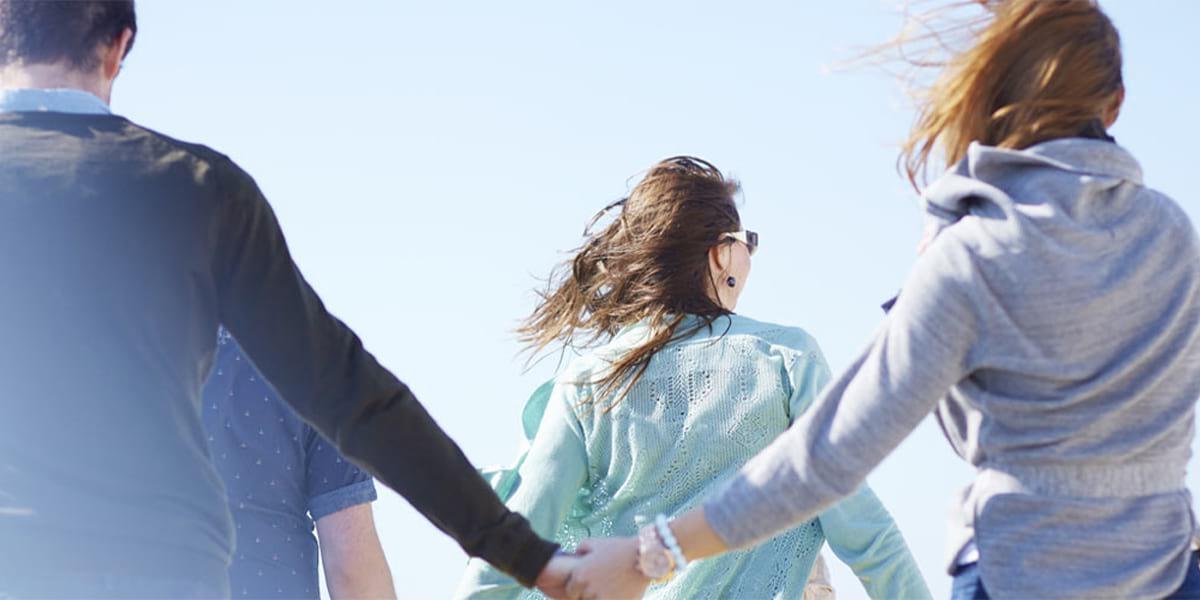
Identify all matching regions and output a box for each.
[517,156,740,410]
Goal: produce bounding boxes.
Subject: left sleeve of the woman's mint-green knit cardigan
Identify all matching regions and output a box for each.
[455,385,588,600]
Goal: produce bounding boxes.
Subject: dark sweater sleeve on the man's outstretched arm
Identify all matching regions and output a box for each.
[212,163,557,586]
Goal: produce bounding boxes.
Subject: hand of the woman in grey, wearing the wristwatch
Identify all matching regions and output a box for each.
[566,538,650,600]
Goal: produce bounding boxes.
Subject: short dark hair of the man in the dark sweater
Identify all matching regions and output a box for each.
[0,0,138,71]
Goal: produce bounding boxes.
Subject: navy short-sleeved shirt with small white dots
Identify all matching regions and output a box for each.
[202,329,377,600]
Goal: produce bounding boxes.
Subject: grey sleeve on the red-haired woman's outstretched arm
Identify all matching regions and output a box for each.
[704,235,980,548]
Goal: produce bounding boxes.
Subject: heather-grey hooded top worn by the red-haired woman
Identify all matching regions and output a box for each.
[706,138,1200,598]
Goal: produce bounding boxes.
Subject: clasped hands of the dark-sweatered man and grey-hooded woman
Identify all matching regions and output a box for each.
[536,538,650,600]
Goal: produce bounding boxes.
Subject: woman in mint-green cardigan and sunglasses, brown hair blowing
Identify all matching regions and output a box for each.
[460,157,929,599]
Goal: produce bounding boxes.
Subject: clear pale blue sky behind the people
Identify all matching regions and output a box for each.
[114,0,1200,599]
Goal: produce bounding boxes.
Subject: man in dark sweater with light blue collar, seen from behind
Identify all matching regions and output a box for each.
[0,0,571,598]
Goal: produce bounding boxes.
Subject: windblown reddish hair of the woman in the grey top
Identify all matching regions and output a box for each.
[896,0,1123,186]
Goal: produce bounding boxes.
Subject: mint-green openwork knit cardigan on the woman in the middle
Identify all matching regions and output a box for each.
[458,316,929,599]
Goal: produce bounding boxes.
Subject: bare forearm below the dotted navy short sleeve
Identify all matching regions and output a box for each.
[317,504,396,600]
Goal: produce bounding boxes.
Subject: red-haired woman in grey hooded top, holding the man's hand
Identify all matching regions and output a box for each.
[568,0,1200,599]
